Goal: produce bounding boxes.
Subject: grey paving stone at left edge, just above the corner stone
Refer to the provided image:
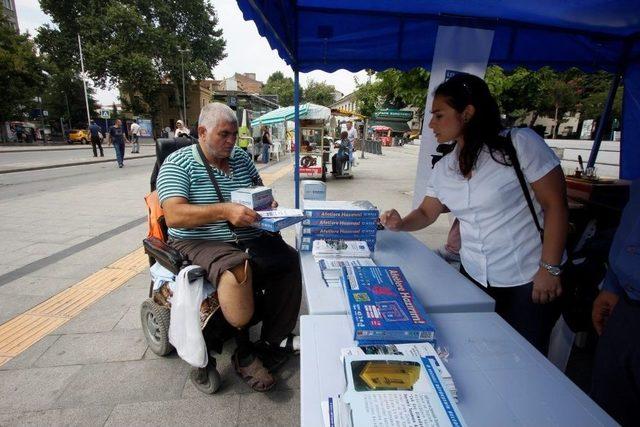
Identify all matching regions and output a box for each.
[0,366,82,412]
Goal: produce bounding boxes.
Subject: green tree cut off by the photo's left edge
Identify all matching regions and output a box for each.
[0,14,45,141]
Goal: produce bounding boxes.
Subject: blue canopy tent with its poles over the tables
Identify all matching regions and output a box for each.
[238,0,640,206]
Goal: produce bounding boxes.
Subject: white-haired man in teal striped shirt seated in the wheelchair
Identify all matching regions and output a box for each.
[157,103,301,391]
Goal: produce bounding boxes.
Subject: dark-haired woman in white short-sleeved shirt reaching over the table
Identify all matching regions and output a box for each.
[380,74,568,354]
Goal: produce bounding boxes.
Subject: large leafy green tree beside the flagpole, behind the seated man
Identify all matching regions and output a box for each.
[37,0,225,130]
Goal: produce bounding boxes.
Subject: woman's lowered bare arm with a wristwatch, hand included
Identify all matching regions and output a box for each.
[531,166,569,303]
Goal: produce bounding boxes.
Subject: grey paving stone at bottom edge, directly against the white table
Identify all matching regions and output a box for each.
[238,390,300,427]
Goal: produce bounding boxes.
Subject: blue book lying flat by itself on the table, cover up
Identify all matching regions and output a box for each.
[343,266,436,345]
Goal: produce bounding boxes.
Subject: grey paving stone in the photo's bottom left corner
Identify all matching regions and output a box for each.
[0,406,113,426]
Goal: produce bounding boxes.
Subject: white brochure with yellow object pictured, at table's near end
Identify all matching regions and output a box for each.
[321,354,466,427]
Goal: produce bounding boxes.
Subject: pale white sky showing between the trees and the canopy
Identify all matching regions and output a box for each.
[16,0,366,105]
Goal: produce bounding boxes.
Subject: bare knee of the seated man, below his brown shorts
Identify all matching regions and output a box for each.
[218,261,254,328]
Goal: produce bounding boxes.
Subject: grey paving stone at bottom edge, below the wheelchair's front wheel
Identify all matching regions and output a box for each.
[105,393,240,426]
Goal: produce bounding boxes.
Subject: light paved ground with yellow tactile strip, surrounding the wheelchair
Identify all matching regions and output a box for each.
[0,146,448,425]
